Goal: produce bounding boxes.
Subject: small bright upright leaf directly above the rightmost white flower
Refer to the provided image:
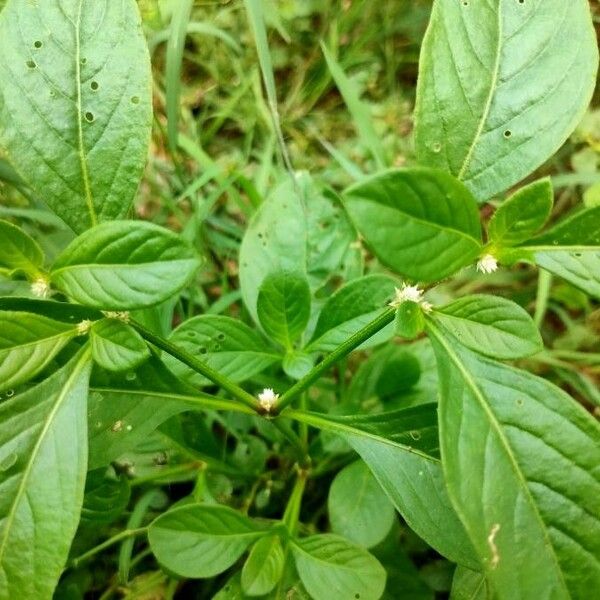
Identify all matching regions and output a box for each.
[488,178,554,246]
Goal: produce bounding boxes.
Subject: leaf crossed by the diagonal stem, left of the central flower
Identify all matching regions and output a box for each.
[165,315,281,386]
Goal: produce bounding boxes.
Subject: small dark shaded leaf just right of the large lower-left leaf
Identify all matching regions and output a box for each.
[81,469,131,523]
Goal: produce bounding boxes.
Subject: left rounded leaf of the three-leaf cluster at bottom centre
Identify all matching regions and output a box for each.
[148,504,268,579]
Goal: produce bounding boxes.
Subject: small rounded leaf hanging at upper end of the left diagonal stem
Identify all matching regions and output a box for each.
[90,319,150,371]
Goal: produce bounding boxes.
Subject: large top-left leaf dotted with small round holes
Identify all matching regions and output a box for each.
[0,0,152,232]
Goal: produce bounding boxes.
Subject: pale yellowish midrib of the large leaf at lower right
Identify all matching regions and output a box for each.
[427,320,570,598]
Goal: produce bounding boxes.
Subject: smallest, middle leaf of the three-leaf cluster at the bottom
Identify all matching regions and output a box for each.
[242,535,285,596]
